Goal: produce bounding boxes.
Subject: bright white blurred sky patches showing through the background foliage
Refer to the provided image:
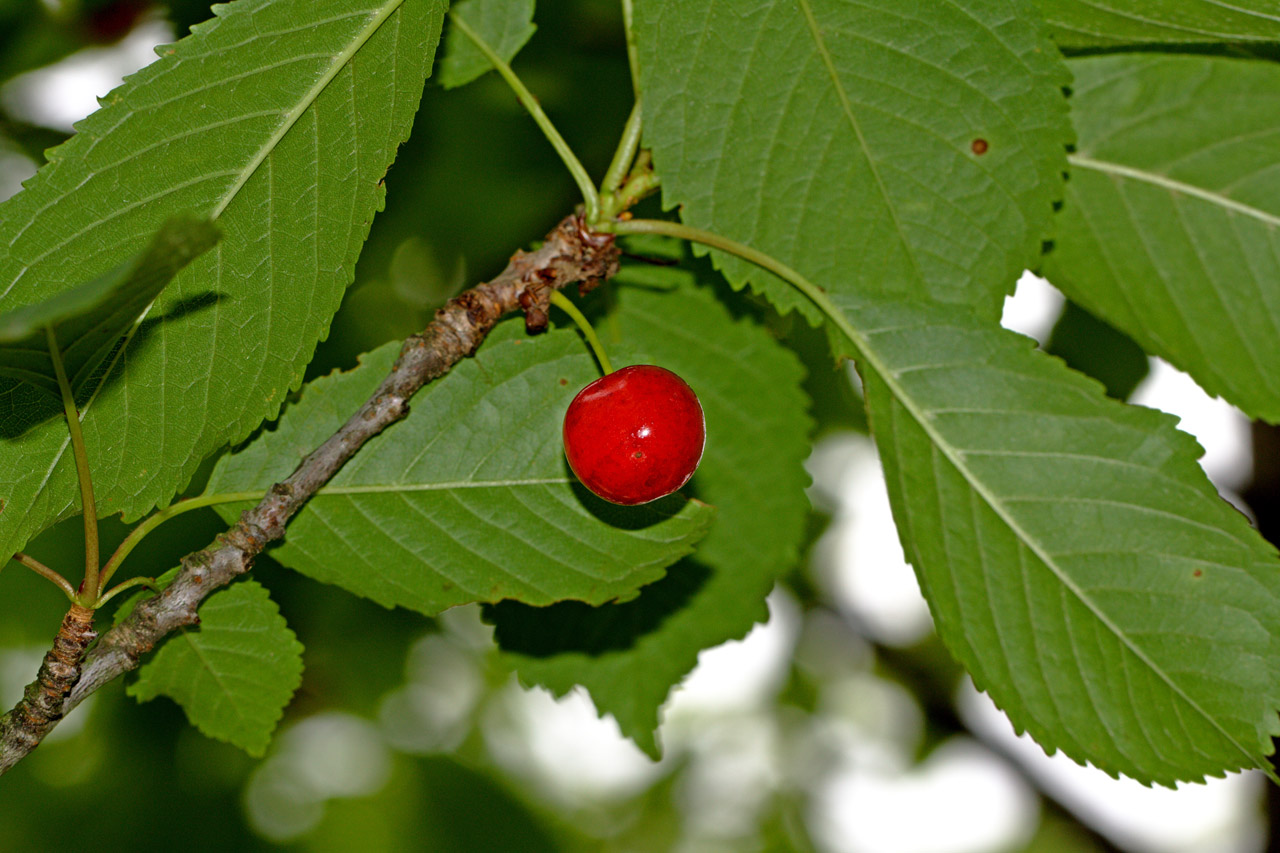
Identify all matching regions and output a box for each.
[0,22,1262,853]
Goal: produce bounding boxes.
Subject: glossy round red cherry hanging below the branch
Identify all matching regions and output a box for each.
[564,364,707,506]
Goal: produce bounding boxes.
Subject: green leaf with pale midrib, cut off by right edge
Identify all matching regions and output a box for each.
[1043,55,1280,423]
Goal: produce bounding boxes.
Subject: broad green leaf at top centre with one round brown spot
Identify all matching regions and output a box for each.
[635,0,1071,318]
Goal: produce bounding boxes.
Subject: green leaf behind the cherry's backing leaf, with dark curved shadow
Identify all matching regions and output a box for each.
[489,257,810,758]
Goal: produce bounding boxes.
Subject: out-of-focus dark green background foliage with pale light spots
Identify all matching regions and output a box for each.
[0,0,1274,853]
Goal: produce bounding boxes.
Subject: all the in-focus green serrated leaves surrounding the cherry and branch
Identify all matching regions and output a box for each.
[0,0,1280,784]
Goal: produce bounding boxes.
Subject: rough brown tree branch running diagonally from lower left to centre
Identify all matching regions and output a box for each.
[0,215,618,774]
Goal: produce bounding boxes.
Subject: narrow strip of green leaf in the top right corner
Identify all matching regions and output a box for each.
[1036,0,1280,47]
